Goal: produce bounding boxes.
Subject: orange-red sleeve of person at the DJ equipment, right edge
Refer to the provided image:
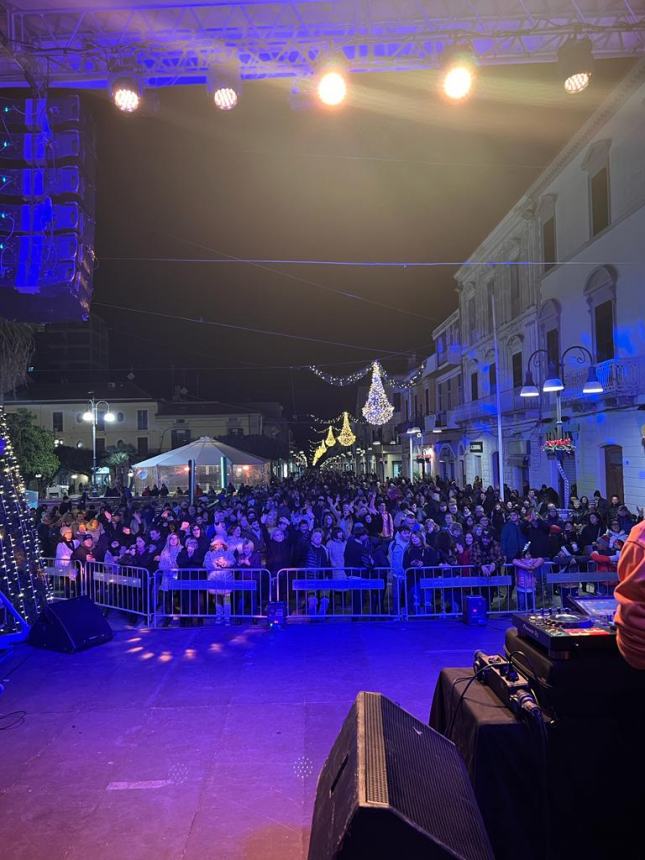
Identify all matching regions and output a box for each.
[614,521,645,669]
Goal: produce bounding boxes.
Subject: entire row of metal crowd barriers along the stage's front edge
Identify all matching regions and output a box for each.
[39,559,618,626]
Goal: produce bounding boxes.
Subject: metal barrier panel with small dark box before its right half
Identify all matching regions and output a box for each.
[402,564,513,618]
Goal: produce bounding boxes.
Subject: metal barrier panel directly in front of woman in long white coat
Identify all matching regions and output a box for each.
[152,567,271,626]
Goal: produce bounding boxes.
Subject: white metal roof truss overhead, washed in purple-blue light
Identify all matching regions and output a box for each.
[0,0,645,88]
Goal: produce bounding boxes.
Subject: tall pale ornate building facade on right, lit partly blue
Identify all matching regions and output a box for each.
[433,61,645,506]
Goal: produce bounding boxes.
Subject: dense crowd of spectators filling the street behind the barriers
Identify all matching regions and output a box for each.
[37,473,643,621]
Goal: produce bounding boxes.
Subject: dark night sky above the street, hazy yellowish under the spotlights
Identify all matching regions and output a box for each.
[89,55,628,422]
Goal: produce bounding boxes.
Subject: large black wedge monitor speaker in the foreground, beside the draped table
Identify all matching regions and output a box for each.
[309,692,493,860]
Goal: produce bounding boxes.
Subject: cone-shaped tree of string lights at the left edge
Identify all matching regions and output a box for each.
[0,408,53,633]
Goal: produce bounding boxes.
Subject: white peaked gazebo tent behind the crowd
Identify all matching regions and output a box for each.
[133,436,271,494]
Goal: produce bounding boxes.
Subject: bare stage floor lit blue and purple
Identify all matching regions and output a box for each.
[0,614,508,860]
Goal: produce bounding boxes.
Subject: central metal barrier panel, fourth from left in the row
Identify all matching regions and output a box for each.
[277,567,400,618]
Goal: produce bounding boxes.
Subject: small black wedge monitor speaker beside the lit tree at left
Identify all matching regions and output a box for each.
[29,597,113,653]
